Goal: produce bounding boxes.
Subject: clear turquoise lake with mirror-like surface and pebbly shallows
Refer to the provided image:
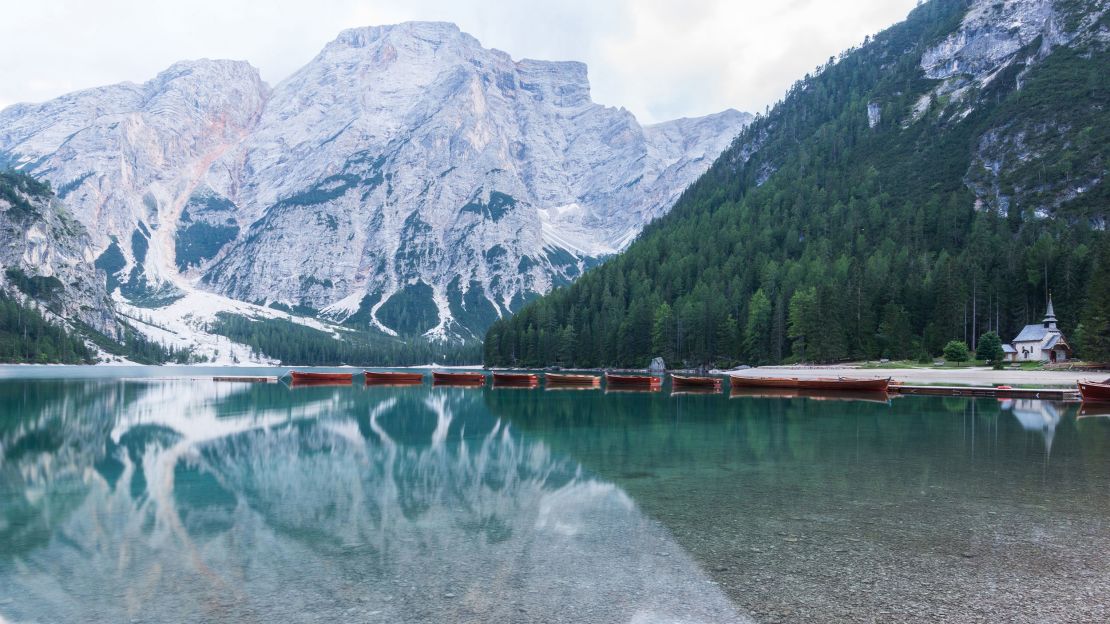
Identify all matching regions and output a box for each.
[0,366,1110,624]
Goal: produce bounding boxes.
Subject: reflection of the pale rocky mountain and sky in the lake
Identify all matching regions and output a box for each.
[0,381,745,622]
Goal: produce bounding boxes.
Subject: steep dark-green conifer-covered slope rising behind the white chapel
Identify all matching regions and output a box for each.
[485,0,1110,366]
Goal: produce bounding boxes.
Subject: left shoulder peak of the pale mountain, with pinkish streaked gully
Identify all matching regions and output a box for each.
[0,60,269,308]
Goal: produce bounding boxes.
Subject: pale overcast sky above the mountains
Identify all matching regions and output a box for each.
[0,0,917,122]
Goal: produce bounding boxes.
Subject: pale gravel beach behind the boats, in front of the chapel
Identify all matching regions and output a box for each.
[727,365,1110,388]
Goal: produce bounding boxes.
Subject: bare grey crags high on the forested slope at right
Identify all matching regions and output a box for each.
[916,0,1110,218]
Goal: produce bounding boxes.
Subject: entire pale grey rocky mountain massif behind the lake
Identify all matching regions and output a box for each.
[0,22,750,336]
